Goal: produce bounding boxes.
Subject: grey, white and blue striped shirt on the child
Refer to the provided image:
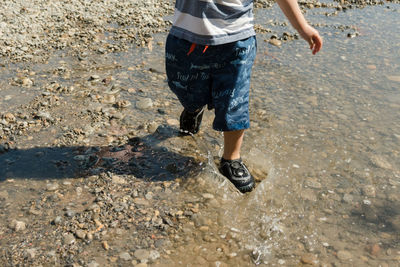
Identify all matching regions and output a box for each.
[170,0,255,45]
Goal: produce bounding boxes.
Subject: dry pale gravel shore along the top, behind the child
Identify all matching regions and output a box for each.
[0,0,398,64]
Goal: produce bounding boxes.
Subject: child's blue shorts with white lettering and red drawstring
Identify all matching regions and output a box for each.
[165,34,257,131]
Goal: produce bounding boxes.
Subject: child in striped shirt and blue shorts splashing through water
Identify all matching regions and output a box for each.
[165,0,322,192]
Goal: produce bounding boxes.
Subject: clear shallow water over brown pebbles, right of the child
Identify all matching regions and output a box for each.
[160,5,400,266]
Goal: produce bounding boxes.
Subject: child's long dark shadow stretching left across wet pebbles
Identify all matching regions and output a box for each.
[0,126,200,182]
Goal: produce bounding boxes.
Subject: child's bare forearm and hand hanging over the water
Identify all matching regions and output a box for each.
[277,0,322,55]
